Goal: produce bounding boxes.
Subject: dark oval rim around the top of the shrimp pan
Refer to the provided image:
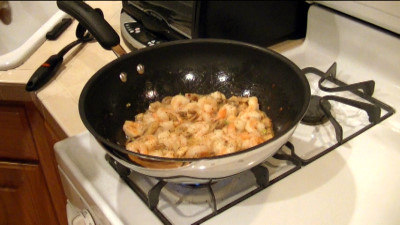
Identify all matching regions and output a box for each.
[78,38,311,163]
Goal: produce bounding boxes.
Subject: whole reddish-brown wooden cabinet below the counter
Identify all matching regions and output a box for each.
[0,101,67,225]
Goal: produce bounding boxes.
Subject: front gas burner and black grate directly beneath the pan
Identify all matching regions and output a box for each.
[105,142,301,224]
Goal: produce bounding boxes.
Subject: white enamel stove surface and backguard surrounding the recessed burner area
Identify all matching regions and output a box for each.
[55,3,400,225]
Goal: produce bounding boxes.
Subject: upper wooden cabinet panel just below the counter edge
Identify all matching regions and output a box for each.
[0,103,38,161]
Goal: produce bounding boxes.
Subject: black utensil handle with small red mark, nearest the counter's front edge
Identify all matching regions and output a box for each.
[25,55,63,91]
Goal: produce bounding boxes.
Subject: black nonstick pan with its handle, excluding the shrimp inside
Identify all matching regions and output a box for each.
[57,1,310,183]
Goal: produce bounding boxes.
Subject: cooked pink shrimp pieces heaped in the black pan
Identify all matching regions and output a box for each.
[123,92,274,158]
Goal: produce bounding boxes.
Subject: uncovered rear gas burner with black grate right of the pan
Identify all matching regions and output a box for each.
[290,63,394,165]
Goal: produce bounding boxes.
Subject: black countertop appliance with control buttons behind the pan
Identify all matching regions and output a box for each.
[121,1,309,48]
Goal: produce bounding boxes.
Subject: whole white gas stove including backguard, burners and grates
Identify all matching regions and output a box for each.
[55,2,400,224]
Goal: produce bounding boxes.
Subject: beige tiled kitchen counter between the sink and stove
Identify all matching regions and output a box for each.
[0,1,128,136]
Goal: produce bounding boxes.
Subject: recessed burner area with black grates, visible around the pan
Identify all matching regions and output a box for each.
[97,59,394,224]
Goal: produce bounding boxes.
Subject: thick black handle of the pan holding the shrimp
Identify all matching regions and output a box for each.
[57,1,120,50]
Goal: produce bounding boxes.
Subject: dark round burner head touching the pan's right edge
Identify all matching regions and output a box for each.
[301,95,331,125]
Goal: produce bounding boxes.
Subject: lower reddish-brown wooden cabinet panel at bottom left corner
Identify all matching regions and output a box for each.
[0,162,58,225]
